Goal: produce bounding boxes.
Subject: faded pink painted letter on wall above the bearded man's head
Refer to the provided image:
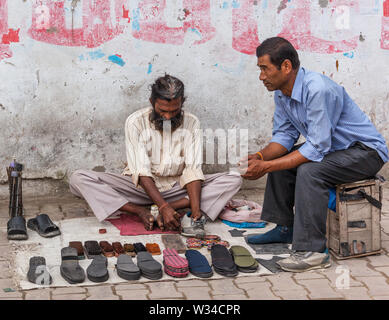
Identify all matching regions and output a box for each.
[132,0,216,45]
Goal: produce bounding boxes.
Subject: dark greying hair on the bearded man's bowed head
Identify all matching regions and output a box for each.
[150,74,185,107]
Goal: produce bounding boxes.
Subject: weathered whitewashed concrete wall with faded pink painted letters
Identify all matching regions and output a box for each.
[0,0,389,196]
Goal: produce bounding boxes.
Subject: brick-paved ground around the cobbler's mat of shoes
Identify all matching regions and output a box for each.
[0,185,389,300]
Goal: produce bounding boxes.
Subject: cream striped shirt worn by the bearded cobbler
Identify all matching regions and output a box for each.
[123,107,204,192]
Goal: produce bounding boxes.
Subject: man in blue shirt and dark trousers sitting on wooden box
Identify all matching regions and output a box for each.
[241,37,388,272]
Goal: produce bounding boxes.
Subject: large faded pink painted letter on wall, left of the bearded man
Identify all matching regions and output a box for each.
[28,0,126,48]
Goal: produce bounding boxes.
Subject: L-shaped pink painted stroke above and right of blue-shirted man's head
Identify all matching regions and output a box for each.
[279,0,358,54]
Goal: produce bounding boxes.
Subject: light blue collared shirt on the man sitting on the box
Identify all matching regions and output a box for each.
[271,68,388,162]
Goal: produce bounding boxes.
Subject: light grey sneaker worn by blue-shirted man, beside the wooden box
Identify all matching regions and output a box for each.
[277,250,331,272]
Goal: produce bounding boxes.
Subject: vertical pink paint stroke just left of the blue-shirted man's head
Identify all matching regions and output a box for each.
[232,0,260,54]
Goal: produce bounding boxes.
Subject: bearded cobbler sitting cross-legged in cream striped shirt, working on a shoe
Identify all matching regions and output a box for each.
[70,75,242,236]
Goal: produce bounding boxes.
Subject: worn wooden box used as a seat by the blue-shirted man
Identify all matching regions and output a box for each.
[327,179,382,259]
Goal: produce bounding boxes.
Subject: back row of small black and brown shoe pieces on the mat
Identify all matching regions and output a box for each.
[69,240,161,260]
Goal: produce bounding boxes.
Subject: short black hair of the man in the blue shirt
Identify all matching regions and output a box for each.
[257,37,300,70]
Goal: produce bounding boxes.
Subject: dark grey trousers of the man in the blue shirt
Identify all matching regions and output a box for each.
[262,143,384,252]
